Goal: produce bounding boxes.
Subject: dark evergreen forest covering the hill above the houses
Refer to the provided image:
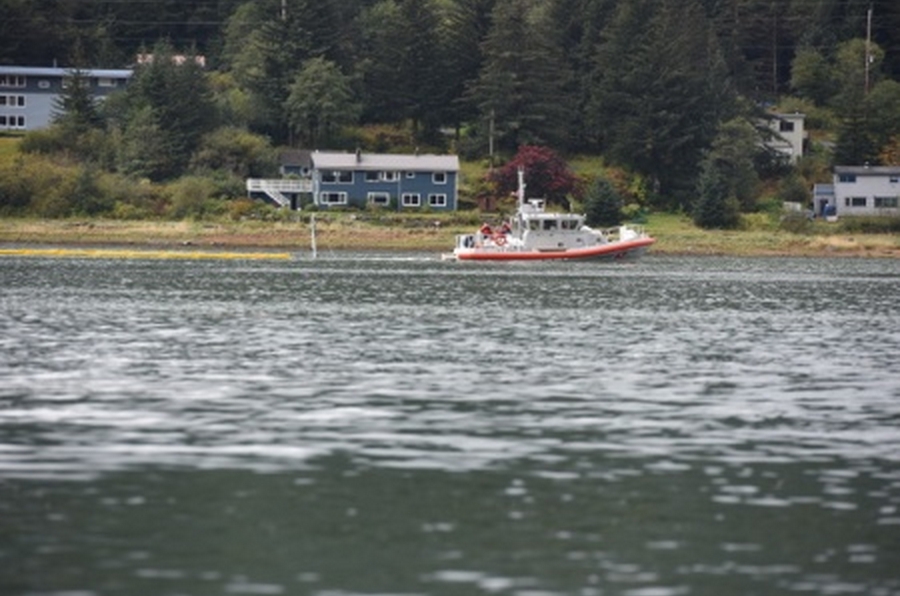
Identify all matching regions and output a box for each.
[0,0,900,214]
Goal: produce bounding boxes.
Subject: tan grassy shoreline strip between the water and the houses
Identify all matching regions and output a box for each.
[0,218,900,258]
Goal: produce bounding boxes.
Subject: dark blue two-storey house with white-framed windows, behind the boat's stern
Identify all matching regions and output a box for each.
[310,151,459,211]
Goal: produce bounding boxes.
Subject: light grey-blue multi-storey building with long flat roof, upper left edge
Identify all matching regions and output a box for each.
[0,66,132,131]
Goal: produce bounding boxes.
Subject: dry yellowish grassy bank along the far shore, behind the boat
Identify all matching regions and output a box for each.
[0,212,900,258]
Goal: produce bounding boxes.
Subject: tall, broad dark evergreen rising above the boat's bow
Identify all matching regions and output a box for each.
[589,0,734,207]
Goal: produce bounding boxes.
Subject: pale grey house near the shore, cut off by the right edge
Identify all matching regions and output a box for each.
[813,166,900,217]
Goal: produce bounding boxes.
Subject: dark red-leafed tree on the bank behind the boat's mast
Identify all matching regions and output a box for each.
[488,145,582,206]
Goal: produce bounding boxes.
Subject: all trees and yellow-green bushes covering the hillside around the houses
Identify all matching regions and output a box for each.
[0,0,900,233]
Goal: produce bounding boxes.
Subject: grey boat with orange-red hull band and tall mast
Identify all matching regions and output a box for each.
[442,169,656,261]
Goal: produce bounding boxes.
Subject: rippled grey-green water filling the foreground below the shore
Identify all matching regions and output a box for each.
[0,255,900,596]
